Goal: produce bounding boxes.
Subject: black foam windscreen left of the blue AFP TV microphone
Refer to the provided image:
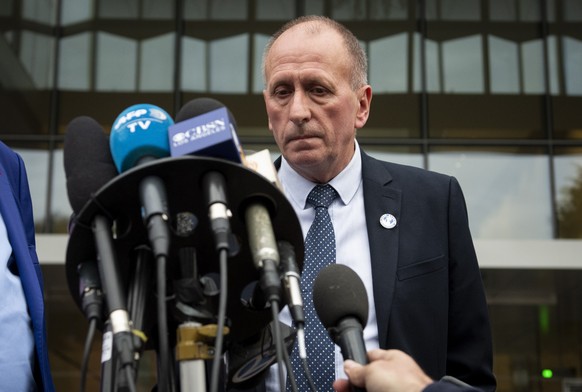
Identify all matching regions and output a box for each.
[63,116,117,213]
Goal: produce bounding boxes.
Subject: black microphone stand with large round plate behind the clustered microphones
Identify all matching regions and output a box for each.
[66,156,304,392]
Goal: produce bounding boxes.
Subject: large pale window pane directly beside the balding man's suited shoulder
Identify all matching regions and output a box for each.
[429,149,553,239]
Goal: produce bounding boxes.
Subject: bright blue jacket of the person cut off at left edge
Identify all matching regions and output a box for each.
[0,142,54,391]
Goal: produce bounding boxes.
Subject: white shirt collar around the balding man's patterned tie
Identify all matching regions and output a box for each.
[279,140,362,209]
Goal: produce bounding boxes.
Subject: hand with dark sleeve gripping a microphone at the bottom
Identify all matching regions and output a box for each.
[333,349,481,392]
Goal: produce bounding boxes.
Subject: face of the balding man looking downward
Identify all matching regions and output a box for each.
[263,25,372,183]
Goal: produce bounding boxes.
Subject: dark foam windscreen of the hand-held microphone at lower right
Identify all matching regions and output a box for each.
[313,264,368,329]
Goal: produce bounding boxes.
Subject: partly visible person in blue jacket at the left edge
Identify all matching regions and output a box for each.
[0,142,54,391]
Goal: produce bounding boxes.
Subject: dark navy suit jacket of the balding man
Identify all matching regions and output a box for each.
[228,152,496,391]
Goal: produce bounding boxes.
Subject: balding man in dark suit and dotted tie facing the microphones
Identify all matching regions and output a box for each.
[263,16,496,391]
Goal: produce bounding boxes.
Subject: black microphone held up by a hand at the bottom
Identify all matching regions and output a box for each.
[313,264,368,364]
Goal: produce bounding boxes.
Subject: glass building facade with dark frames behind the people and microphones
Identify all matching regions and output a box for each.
[0,0,582,391]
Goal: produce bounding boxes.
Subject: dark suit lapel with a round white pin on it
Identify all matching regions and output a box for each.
[362,152,402,348]
